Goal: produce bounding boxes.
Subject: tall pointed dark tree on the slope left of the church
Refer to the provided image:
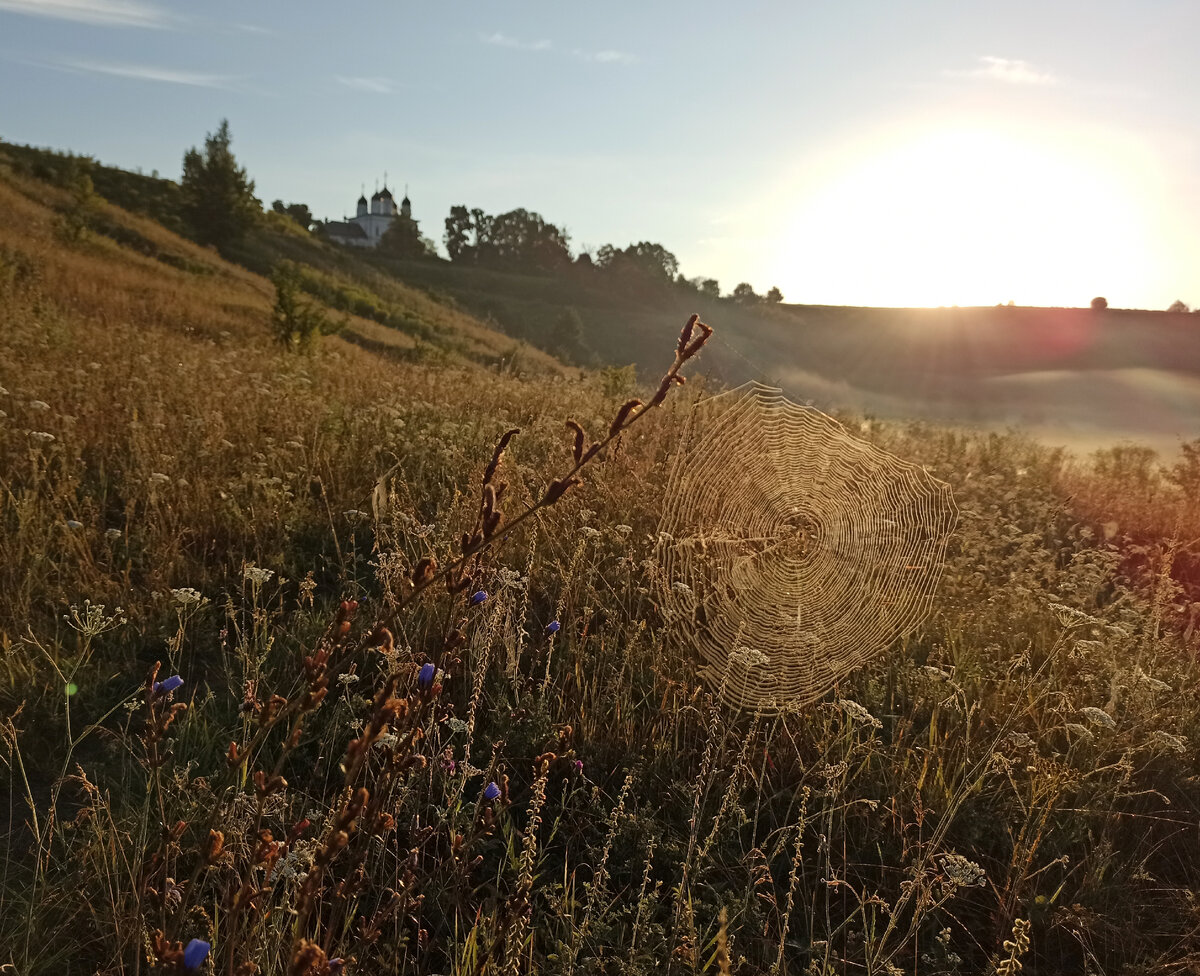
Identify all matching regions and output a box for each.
[180,119,262,247]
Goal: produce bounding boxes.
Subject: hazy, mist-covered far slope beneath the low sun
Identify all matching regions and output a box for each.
[367,250,1200,451]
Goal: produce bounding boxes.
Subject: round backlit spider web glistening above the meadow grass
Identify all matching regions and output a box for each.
[656,383,958,712]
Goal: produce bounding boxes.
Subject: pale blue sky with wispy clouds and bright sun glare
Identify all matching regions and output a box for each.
[0,0,1200,309]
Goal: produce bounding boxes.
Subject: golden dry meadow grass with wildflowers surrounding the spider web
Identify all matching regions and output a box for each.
[0,162,1200,976]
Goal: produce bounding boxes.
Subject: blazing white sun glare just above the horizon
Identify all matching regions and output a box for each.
[770,126,1159,305]
